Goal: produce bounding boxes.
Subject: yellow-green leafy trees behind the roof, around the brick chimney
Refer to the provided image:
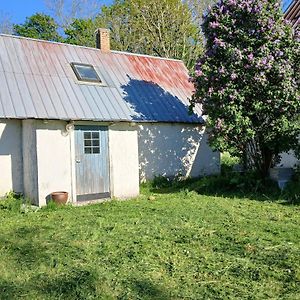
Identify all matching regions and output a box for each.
[65,0,202,67]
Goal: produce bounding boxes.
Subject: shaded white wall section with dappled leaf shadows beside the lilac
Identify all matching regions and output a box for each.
[138,123,220,181]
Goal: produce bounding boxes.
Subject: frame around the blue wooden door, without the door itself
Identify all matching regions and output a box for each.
[69,121,113,203]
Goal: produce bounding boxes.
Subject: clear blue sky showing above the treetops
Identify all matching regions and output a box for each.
[0,0,292,23]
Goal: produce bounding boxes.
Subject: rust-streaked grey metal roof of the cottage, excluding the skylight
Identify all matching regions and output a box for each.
[0,35,202,123]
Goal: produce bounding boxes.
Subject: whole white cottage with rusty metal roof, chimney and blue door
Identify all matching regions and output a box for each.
[0,29,220,206]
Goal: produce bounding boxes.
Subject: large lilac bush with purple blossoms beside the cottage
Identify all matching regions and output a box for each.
[191,0,300,177]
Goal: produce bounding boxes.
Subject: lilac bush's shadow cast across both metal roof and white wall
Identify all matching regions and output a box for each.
[122,79,220,181]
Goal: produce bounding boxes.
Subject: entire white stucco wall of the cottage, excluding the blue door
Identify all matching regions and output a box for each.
[0,120,220,206]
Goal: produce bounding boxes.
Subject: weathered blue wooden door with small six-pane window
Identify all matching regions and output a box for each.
[75,126,110,201]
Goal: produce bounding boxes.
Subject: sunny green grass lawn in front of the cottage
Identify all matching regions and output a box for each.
[0,189,300,300]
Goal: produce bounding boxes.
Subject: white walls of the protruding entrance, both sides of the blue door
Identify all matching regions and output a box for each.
[23,120,139,206]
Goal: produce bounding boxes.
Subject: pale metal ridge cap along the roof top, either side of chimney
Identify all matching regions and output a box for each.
[0,33,183,62]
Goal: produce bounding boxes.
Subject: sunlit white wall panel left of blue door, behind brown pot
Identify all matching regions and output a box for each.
[36,121,72,206]
